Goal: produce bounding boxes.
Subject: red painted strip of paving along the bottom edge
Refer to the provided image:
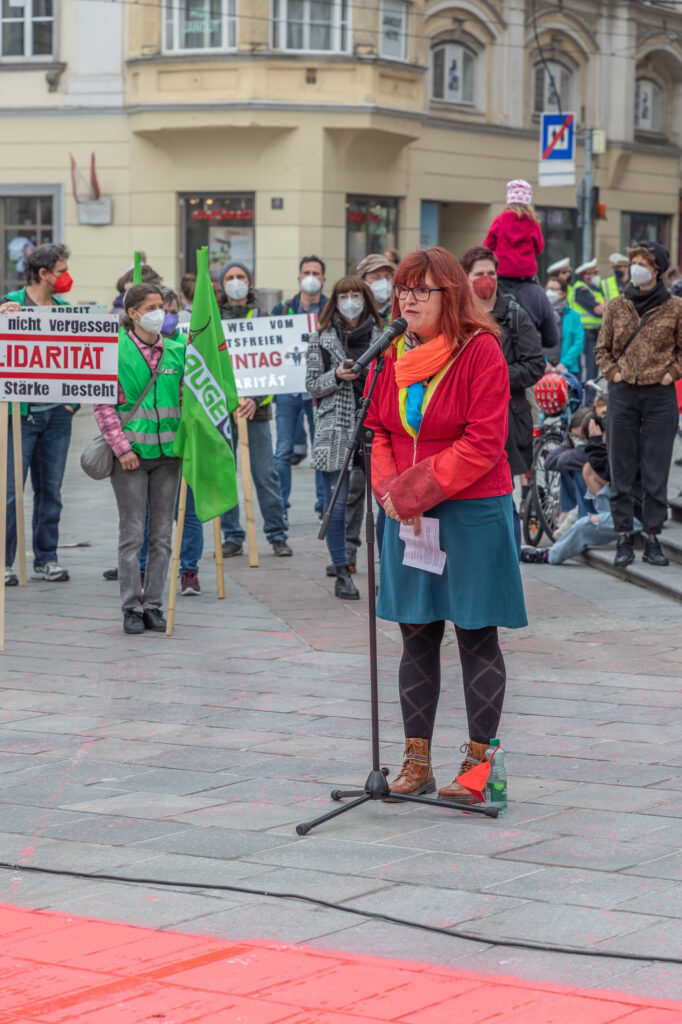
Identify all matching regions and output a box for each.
[0,905,682,1024]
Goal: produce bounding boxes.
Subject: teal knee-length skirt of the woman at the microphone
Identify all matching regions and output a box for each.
[377,495,527,630]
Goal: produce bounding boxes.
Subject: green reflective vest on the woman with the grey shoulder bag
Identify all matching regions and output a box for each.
[117,328,185,459]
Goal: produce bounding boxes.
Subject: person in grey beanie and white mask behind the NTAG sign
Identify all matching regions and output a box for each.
[218,260,294,558]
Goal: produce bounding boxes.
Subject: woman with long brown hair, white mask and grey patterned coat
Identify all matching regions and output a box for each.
[305,276,382,601]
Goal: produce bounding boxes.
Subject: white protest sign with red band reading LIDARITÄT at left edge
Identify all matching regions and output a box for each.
[0,306,119,404]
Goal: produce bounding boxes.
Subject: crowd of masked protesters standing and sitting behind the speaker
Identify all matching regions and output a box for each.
[0,186,682,632]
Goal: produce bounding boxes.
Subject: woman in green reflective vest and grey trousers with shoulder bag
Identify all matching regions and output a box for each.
[94,285,185,634]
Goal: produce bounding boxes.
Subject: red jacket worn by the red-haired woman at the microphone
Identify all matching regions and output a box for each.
[367,333,512,518]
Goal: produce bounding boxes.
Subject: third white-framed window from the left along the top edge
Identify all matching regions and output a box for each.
[272,0,350,52]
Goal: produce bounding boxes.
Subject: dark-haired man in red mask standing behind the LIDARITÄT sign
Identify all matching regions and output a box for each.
[0,243,79,587]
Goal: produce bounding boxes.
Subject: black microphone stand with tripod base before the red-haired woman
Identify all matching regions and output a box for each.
[296,355,500,836]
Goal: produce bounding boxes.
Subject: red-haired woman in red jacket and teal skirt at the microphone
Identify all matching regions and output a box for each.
[367,246,526,803]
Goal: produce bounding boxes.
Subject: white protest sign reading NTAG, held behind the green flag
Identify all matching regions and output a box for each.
[180,313,317,398]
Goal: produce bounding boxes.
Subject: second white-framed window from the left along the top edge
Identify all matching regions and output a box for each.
[163,0,237,53]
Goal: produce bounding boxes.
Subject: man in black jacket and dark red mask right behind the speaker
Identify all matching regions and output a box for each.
[460,246,547,551]
